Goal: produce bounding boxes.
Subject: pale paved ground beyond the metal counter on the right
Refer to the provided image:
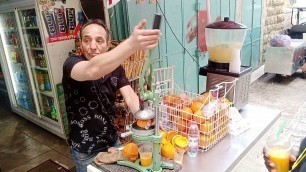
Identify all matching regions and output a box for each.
[233,72,306,172]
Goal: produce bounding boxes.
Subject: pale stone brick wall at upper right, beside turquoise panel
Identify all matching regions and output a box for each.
[262,0,291,62]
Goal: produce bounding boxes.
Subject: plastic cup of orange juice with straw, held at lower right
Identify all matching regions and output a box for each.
[266,135,292,172]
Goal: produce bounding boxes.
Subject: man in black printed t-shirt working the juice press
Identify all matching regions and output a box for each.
[62,19,161,172]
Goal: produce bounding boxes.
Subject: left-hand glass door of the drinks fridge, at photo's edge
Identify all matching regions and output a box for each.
[0,12,36,115]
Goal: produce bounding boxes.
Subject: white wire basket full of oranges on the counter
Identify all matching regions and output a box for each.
[154,67,236,151]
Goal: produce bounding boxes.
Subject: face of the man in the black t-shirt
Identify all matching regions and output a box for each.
[81,24,108,60]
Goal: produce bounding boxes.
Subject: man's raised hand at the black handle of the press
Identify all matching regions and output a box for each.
[128,20,161,50]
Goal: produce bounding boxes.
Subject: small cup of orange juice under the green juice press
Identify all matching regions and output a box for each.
[138,144,153,167]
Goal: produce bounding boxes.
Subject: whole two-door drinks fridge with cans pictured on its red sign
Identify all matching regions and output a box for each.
[0,0,80,138]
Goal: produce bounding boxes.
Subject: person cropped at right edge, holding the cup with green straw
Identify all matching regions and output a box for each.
[263,137,306,172]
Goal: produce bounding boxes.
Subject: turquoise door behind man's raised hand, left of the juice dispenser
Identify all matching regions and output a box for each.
[128,0,199,93]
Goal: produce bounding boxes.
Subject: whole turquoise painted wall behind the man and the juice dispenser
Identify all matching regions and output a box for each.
[109,0,261,93]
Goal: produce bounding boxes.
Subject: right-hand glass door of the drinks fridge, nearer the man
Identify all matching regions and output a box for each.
[18,9,58,121]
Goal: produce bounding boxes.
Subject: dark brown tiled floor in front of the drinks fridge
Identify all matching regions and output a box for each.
[0,106,74,172]
